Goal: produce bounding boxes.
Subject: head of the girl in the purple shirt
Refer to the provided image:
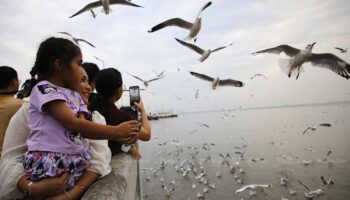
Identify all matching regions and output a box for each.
[30,37,82,89]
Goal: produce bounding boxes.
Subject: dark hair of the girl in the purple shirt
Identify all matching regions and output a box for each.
[30,37,81,80]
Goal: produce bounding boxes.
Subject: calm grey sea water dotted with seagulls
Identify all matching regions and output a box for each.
[140,103,350,200]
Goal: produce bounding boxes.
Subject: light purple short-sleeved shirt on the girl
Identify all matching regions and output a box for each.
[27,81,88,154]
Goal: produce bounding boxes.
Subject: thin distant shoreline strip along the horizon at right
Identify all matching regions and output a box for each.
[180,101,350,114]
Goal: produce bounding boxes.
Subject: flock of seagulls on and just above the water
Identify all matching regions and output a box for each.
[141,117,335,200]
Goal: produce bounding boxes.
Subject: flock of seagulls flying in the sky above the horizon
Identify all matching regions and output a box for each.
[60,0,350,90]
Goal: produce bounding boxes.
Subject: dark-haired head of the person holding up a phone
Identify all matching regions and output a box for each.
[96,68,123,101]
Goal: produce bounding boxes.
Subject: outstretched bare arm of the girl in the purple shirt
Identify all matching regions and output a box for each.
[44,100,138,141]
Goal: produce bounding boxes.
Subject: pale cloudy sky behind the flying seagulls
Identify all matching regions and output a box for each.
[0,0,350,113]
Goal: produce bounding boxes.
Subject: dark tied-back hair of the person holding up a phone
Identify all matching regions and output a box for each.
[89,68,123,117]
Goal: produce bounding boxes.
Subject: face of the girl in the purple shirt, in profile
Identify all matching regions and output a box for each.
[65,53,83,91]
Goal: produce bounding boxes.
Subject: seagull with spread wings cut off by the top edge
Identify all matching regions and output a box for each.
[69,0,142,18]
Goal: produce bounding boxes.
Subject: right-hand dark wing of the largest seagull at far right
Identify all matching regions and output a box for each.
[309,53,350,79]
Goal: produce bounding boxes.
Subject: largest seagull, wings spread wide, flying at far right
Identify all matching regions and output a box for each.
[253,42,350,79]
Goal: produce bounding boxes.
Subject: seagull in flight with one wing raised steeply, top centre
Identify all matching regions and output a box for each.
[148,1,212,42]
